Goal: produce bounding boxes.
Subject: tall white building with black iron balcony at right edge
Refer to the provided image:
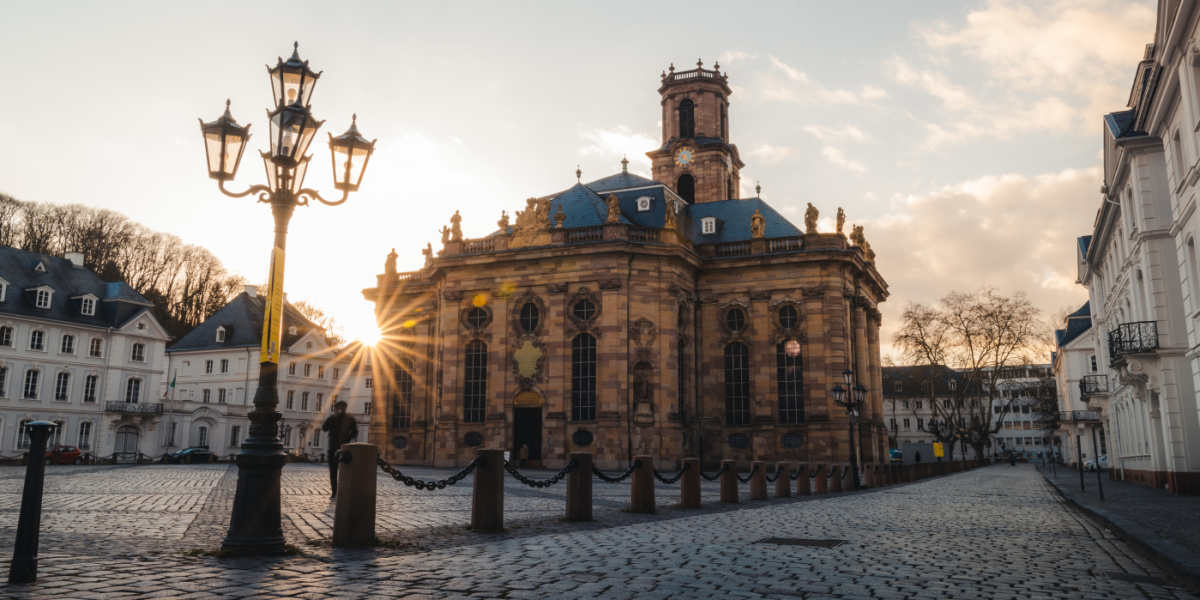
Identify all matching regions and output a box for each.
[1076,1,1200,493]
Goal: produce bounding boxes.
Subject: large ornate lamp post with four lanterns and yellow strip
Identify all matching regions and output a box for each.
[200,42,374,554]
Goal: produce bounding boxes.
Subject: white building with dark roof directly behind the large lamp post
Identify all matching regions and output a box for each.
[166,286,350,456]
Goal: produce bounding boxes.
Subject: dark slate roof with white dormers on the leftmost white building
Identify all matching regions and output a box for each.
[0,246,154,328]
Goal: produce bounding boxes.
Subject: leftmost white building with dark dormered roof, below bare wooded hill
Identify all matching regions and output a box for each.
[0,247,169,460]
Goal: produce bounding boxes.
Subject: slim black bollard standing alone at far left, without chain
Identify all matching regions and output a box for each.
[8,421,56,583]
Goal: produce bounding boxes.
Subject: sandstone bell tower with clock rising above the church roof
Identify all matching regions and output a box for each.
[646,60,745,203]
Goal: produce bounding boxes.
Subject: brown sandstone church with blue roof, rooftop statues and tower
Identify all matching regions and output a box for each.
[364,62,888,469]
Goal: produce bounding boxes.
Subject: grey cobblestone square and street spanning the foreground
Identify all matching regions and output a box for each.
[0,464,1196,599]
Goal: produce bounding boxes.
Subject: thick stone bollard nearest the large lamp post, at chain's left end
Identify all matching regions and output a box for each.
[334,443,379,546]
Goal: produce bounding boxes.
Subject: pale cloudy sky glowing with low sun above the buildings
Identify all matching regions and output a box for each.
[0,0,1154,360]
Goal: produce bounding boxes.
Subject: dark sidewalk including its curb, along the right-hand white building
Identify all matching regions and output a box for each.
[1039,466,1200,589]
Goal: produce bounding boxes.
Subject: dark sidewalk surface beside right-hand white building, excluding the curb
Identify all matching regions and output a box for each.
[1043,467,1200,553]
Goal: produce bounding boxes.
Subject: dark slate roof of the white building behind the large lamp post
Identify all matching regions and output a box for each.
[167,292,324,352]
